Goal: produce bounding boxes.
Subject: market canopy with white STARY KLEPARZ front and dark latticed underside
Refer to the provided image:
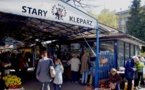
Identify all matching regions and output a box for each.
[0,0,100,43]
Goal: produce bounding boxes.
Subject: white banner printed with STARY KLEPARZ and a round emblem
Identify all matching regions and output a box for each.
[0,0,98,29]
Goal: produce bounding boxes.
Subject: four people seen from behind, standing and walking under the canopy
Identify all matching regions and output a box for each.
[36,51,93,90]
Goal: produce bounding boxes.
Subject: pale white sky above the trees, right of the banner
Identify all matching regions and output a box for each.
[80,0,145,14]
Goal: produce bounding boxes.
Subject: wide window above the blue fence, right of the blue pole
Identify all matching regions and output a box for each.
[100,41,114,53]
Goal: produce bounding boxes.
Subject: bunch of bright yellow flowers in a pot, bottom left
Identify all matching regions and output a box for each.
[3,75,22,89]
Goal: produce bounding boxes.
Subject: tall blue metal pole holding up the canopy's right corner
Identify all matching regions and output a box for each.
[95,29,99,88]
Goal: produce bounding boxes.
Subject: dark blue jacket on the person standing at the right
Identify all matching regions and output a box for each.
[125,59,135,79]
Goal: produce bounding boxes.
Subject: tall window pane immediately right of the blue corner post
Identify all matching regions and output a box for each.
[118,41,124,67]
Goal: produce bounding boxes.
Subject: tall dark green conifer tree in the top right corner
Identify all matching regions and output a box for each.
[126,0,145,41]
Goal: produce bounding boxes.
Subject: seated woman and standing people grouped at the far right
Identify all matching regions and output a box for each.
[104,56,145,90]
